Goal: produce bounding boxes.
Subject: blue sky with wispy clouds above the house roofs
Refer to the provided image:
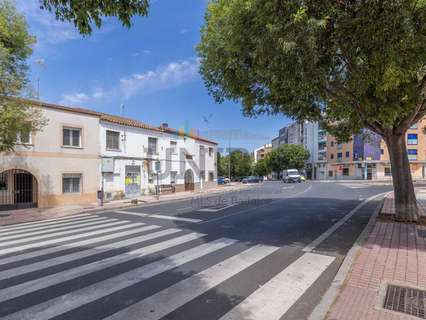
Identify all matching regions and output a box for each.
[15,0,289,151]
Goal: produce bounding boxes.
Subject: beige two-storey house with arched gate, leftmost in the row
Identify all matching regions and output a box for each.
[0,102,100,210]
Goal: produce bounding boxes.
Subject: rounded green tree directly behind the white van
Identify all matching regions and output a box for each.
[266,144,309,172]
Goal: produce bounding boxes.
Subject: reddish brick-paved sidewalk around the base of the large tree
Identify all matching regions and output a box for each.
[327,189,426,320]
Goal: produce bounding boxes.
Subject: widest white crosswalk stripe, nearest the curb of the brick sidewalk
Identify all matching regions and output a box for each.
[220,253,335,320]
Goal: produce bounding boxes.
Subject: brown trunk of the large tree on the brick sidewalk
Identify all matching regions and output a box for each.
[385,134,419,222]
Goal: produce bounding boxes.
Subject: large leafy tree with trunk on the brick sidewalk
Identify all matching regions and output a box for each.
[198,0,426,221]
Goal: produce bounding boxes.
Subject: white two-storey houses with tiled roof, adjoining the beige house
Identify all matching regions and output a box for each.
[100,115,217,199]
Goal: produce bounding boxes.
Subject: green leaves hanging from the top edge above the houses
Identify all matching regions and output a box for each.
[40,0,149,35]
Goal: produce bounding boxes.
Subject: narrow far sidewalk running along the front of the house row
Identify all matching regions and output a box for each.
[0,184,250,226]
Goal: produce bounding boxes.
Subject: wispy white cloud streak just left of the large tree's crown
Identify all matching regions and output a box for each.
[120,58,199,98]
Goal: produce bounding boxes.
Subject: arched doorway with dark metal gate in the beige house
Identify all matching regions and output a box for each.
[0,169,38,210]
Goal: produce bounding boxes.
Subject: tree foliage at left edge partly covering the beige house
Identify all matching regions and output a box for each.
[0,0,45,152]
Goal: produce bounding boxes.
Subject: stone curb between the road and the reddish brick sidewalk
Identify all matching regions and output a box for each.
[308,193,388,320]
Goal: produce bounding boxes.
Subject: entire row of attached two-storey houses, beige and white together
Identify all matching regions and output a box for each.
[0,101,217,210]
